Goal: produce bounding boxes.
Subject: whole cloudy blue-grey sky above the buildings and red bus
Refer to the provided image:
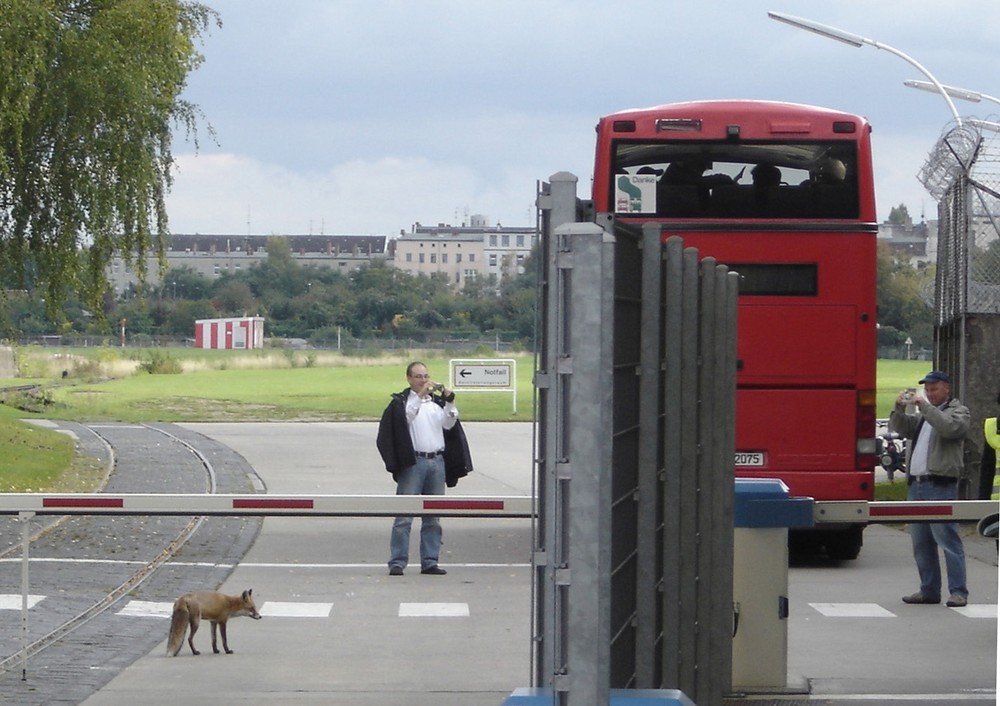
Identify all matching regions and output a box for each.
[168,0,1000,235]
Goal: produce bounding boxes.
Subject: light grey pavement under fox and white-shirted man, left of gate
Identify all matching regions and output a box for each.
[85,423,531,706]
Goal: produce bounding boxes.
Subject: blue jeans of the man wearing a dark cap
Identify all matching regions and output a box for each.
[907,476,969,598]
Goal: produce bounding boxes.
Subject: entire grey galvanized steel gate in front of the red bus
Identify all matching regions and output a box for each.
[533,173,737,706]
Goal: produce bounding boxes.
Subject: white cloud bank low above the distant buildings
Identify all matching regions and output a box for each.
[168,153,536,235]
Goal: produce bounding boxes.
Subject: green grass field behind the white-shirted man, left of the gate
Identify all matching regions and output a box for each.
[0,348,534,422]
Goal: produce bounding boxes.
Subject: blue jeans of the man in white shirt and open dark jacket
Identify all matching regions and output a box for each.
[389,456,445,569]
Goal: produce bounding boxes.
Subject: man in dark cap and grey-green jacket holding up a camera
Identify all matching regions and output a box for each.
[889,370,970,608]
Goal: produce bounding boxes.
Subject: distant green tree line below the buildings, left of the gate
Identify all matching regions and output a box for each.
[8,237,537,349]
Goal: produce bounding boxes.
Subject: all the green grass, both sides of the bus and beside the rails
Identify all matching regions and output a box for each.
[0,348,930,492]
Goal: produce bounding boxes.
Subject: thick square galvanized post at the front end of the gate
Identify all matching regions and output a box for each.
[556,223,614,706]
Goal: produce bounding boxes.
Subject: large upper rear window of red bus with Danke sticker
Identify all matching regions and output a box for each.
[611,140,859,219]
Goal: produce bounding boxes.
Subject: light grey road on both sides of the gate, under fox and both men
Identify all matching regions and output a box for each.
[0,423,997,706]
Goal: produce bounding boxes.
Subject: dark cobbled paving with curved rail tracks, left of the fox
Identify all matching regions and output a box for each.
[0,423,260,704]
